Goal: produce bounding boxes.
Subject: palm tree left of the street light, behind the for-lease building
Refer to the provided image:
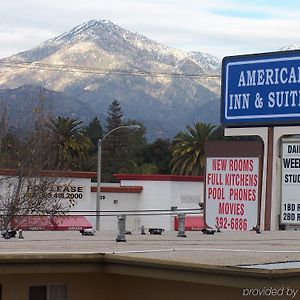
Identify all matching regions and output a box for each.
[46,117,92,169]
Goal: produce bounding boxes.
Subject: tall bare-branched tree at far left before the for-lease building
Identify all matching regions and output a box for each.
[0,95,75,229]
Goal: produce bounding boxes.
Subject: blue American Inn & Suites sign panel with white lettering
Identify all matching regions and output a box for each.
[221,51,300,126]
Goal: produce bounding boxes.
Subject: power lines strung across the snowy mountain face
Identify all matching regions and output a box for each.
[0,60,221,79]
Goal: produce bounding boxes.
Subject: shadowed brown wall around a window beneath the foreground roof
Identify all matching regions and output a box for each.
[0,273,243,300]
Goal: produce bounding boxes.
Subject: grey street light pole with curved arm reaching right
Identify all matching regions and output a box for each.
[96,125,141,231]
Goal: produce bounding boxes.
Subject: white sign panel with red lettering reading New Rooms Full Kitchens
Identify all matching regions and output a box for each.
[205,157,259,230]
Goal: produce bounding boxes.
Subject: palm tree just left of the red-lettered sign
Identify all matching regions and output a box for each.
[170,123,216,175]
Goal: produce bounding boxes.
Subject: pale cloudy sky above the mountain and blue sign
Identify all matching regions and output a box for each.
[0,0,300,59]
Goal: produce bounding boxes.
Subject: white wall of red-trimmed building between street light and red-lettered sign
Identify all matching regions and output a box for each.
[89,176,204,231]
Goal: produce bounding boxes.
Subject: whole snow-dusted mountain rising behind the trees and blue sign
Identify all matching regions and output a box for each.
[0,20,221,138]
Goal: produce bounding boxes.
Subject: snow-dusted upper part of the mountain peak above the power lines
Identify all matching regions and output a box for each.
[10,19,220,73]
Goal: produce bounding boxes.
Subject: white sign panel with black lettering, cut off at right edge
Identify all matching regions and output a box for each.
[281,142,300,224]
